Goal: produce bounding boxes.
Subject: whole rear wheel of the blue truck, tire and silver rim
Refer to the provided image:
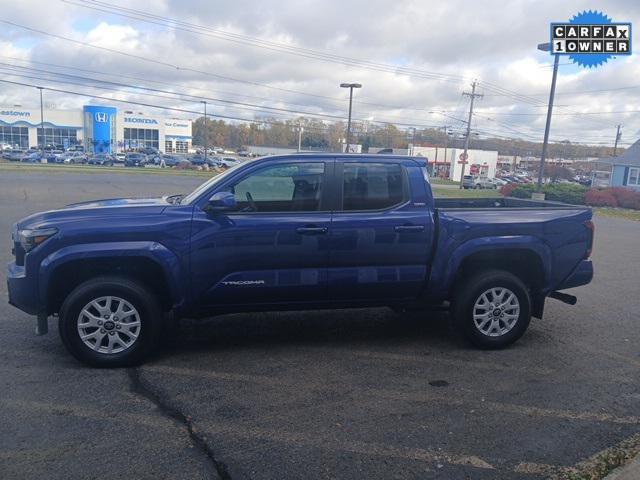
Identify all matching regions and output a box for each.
[452,270,531,349]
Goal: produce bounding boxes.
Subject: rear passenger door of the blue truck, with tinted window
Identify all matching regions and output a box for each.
[328,158,433,301]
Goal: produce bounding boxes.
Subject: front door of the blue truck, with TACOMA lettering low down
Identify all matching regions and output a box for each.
[191,159,333,307]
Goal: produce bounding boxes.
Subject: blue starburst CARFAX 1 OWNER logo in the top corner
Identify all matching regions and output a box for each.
[551,10,631,68]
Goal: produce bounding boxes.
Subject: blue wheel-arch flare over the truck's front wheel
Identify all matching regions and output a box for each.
[38,241,186,305]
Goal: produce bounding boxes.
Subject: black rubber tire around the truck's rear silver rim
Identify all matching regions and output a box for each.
[451,270,531,349]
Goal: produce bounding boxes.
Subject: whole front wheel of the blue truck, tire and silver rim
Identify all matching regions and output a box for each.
[59,277,162,367]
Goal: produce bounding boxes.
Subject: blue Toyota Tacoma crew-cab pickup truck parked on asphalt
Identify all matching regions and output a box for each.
[7,154,594,367]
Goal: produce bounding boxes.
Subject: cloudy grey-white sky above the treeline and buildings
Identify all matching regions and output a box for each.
[0,0,640,146]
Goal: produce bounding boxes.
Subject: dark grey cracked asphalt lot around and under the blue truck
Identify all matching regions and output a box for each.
[0,171,640,479]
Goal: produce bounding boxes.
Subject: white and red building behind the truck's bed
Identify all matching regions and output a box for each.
[412,146,498,182]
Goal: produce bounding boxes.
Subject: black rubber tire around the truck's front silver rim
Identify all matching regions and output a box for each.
[58,276,164,368]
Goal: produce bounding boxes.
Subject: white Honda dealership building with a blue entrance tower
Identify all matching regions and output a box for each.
[0,105,192,153]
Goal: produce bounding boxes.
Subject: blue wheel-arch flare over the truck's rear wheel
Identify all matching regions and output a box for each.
[431,235,553,296]
